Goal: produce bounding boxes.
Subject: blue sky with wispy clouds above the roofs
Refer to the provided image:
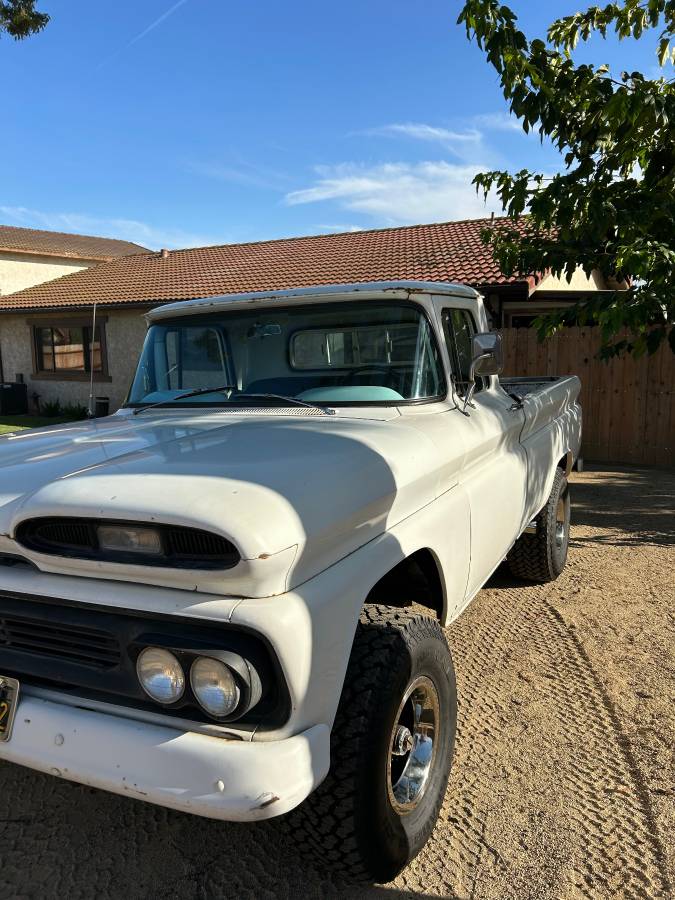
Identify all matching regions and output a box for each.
[0,0,656,248]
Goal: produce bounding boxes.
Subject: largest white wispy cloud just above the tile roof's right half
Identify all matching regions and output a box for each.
[285,160,500,225]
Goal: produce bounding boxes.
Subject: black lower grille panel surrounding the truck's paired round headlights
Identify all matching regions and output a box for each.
[0,586,290,730]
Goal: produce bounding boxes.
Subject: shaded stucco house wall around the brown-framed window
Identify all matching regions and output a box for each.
[0,309,146,412]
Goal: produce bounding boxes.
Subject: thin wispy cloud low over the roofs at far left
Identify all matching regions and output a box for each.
[0,206,227,250]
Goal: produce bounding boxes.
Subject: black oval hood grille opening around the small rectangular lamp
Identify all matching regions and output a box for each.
[16,518,240,569]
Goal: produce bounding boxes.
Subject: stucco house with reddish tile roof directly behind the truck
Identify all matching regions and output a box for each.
[0,219,610,409]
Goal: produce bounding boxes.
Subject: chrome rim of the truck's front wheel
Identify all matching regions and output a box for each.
[387,675,440,814]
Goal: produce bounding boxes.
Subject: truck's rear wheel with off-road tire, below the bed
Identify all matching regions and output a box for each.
[506,469,570,584]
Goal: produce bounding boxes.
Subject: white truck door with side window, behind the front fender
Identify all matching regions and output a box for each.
[441,307,527,597]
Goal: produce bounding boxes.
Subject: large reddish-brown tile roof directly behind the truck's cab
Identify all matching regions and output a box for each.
[0,219,535,312]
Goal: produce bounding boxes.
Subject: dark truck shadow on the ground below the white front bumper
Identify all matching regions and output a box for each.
[0,764,460,900]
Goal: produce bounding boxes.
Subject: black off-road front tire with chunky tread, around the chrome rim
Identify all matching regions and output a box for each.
[289,605,457,883]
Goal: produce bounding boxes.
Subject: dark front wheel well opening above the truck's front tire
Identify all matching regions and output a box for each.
[366,549,444,619]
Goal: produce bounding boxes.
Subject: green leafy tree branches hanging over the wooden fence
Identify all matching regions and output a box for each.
[460,0,675,358]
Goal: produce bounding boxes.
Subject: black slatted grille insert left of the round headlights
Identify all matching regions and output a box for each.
[0,615,120,669]
